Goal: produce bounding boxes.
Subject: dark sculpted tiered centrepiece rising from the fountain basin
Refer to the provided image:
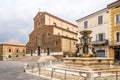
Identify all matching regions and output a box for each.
[75,30,96,57]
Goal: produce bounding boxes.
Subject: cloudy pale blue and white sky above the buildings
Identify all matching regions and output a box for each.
[0,0,116,44]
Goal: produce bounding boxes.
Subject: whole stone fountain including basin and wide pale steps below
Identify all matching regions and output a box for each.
[27,30,120,80]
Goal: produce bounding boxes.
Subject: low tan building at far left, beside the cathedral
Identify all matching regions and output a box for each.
[0,43,26,60]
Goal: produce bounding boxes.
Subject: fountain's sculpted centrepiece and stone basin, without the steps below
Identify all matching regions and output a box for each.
[63,30,114,67]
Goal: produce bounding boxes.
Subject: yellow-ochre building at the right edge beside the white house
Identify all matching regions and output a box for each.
[107,0,120,61]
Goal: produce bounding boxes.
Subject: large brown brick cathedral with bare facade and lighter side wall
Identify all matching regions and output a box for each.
[26,12,77,55]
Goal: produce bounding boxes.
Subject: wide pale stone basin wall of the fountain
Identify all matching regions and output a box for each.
[63,57,114,67]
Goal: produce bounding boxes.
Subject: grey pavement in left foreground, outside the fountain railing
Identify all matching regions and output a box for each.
[0,61,49,80]
